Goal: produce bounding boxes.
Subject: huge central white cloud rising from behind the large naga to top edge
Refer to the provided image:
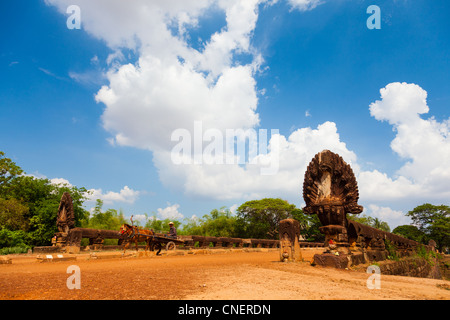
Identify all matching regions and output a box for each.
[47,0,338,205]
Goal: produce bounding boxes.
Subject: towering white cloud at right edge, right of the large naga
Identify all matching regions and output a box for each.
[359,82,450,199]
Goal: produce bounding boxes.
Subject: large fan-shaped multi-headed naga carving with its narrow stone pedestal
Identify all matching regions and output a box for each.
[303,150,363,246]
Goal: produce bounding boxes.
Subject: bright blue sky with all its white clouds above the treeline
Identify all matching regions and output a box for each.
[0,0,450,228]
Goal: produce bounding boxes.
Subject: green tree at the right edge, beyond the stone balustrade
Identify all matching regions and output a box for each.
[406,203,450,251]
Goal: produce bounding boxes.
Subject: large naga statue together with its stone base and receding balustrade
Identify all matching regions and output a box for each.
[303,150,432,268]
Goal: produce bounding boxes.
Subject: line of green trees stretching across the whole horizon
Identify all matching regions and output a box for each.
[0,151,450,252]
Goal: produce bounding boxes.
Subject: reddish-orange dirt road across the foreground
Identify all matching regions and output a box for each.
[0,251,450,300]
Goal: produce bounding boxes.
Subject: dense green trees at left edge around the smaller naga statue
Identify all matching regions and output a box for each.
[0,151,88,246]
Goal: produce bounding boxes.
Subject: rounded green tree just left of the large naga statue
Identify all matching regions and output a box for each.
[236,198,298,239]
